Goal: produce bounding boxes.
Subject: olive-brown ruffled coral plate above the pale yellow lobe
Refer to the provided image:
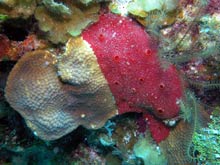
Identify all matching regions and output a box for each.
[35,1,99,43]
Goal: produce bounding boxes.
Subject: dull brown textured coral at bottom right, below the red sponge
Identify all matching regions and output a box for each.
[159,90,209,164]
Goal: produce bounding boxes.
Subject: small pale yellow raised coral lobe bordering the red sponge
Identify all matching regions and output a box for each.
[57,37,107,92]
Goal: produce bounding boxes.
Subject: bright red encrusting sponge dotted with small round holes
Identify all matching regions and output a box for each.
[82,14,182,119]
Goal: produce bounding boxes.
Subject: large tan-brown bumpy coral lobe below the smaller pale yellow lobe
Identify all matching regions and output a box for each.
[6,40,117,140]
